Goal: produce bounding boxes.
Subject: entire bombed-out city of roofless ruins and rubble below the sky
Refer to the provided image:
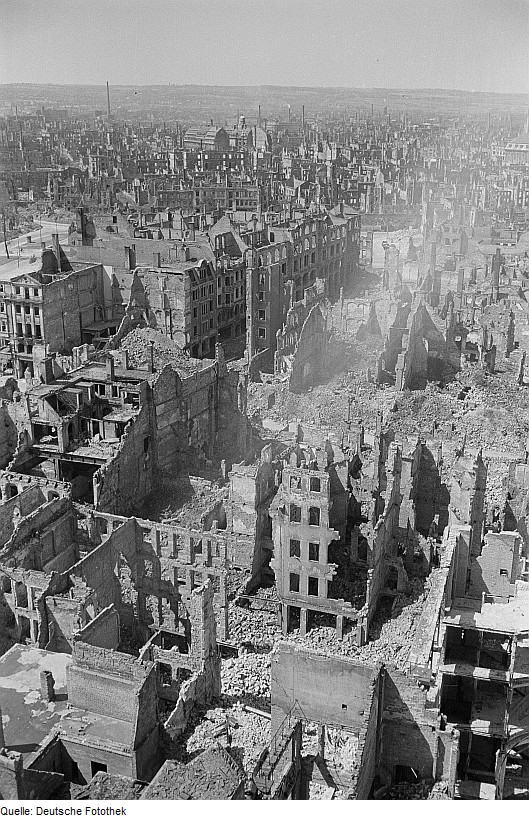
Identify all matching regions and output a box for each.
[0,83,529,801]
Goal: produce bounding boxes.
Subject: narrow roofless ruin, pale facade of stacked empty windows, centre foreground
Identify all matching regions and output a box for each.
[270,430,406,645]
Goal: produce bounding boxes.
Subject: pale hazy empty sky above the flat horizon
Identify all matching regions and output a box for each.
[0,0,529,92]
